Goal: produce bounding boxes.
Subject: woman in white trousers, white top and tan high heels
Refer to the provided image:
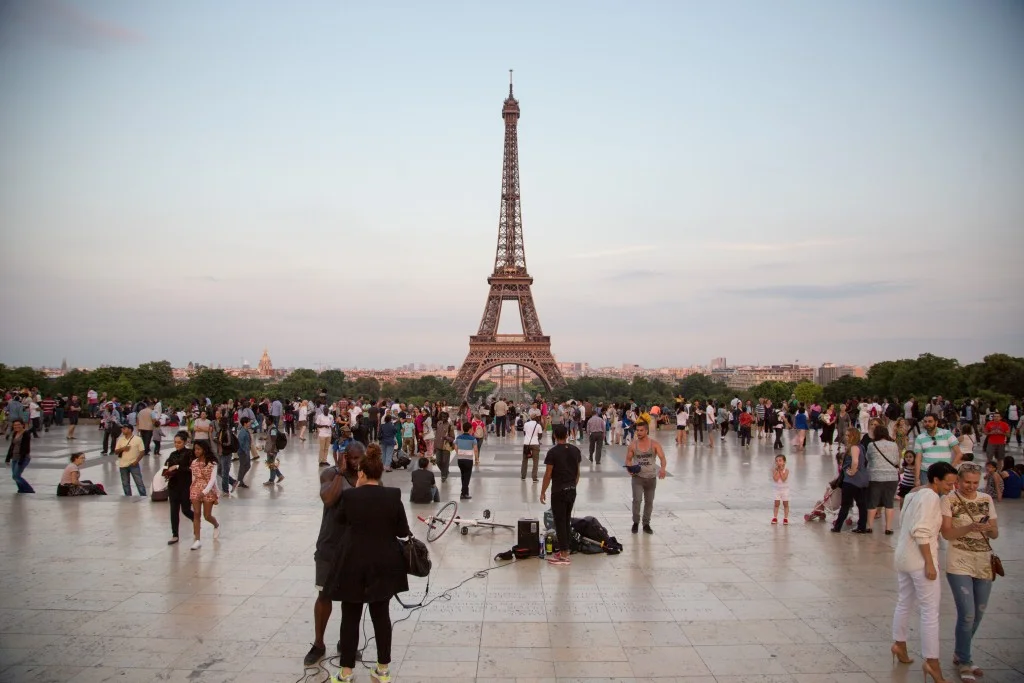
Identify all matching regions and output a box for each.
[891,462,956,683]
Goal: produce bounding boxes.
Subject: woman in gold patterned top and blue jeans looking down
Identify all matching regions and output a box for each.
[941,463,999,681]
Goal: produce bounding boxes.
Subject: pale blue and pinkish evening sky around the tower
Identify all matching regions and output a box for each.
[0,0,1024,374]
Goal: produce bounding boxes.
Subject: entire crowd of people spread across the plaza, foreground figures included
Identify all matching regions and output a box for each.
[0,389,1024,682]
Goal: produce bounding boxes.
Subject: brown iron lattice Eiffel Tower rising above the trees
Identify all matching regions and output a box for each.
[455,71,565,399]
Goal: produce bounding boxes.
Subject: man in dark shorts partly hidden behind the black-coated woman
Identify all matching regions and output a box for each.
[302,440,367,667]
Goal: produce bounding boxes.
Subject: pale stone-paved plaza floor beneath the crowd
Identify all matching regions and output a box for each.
[0,427,1024,683]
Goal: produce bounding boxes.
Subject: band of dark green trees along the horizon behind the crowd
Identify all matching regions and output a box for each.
[0,353,1024,405]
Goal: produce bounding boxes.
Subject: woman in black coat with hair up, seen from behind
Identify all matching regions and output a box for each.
[324,443,412,681]
